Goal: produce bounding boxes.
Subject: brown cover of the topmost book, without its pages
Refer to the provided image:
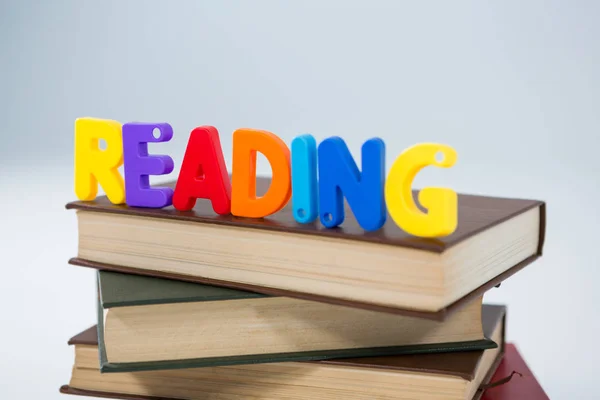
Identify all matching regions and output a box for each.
[66,178,546,320]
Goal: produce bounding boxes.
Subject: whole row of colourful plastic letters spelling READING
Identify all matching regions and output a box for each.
[75,118,458,237]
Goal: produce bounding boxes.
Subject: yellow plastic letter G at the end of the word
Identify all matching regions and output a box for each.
[385,143,458,237]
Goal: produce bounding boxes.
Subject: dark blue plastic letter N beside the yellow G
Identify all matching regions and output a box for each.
[318,137,386,231]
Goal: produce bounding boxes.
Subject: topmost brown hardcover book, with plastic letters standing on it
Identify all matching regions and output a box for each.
[67,178,545,320]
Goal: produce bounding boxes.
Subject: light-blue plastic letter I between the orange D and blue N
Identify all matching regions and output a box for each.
[291,135,319,224]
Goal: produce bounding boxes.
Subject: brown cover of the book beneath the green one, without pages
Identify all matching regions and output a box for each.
[60,305,506,400]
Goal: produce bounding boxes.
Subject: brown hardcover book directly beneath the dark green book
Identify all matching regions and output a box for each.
[61,306,506,400]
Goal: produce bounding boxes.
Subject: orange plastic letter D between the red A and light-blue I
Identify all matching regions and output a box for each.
[231,129,292,218]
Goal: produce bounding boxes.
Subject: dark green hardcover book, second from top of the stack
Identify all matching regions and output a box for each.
[98,271,497,372]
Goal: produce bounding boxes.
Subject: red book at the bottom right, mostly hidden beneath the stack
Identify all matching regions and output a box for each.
[481,343,549,400]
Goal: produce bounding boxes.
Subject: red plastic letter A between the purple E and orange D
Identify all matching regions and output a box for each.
[173,126,231,215]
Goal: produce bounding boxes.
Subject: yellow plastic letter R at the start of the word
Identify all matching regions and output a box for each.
[75,118,125,204]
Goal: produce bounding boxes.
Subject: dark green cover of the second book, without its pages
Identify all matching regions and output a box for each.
[98,271,497,372]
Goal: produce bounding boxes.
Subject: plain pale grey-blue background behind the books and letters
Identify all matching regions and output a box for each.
[0,1,600,400]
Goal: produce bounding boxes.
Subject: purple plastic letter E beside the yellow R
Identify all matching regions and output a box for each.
[123,122,173,208]
